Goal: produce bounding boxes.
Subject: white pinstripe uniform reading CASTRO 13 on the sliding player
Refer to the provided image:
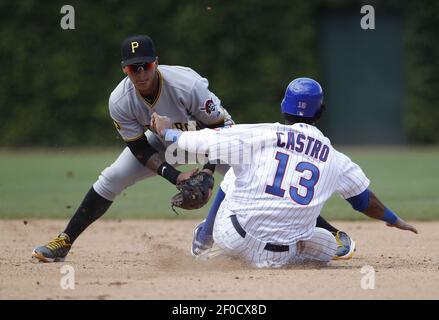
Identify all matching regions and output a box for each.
[178,123,370,267]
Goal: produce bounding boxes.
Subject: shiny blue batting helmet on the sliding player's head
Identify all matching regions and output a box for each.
[281,78,323,118]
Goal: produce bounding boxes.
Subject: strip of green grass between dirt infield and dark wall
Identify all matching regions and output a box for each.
[0,147,439,220]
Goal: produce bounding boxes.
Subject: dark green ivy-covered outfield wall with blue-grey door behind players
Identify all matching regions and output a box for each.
[0,0,439,147]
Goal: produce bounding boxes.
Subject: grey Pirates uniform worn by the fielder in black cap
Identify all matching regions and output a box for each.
[93,65,233,201]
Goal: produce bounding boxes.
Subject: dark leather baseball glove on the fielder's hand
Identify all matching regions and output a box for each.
[171,172,215,211]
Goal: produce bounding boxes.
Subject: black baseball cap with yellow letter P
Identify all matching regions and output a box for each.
[121,35,157,67]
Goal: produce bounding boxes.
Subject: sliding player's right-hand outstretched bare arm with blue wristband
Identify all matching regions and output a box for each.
[347,189,418,233]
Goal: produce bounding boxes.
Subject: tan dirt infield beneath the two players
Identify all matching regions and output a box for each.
[0,220,439,299]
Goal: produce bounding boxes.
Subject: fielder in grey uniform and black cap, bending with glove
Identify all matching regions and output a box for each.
[32,35,353,262]
